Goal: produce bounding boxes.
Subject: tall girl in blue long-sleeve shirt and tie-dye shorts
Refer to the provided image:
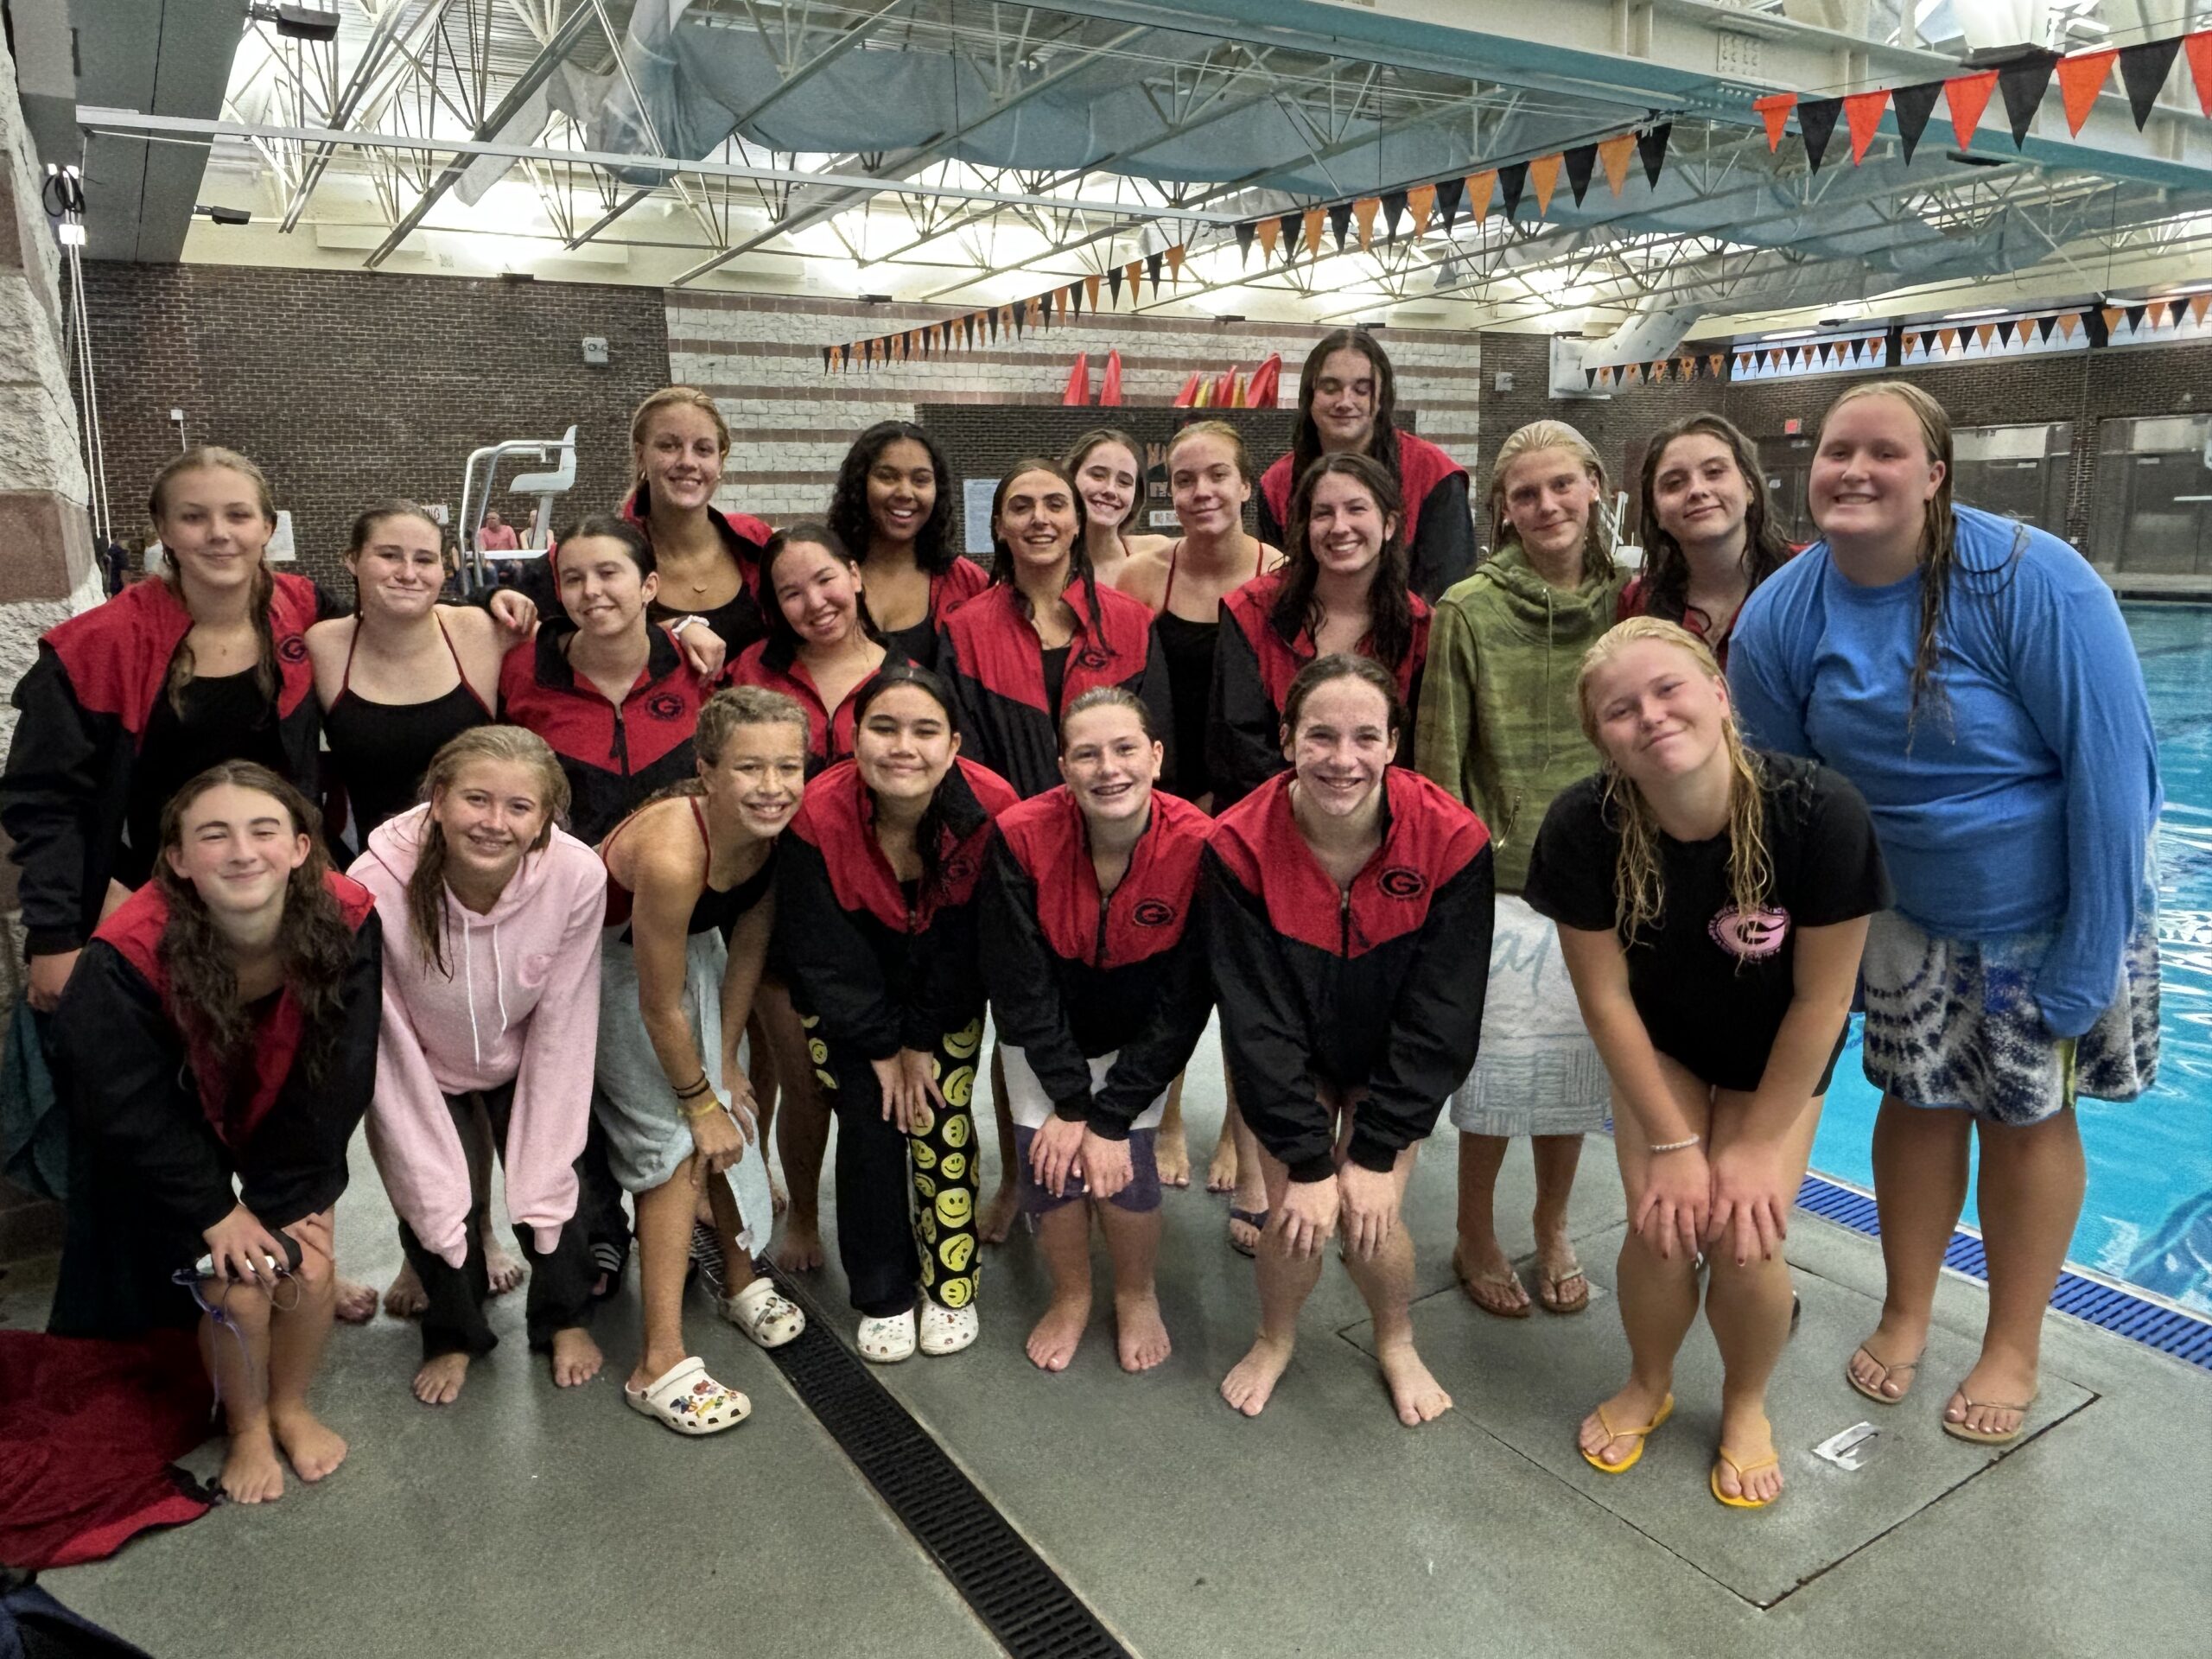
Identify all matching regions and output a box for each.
[1730,380,2159,1445]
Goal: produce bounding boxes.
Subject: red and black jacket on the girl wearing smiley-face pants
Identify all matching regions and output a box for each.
[777,759,1015,1059]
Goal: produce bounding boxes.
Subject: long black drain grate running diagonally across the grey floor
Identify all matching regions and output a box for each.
[761,1263,1128,1659]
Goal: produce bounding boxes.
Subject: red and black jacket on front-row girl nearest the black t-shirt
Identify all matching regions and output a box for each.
[1204,766,1493,1181]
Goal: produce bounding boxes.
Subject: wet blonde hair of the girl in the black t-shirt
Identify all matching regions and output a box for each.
[1575,617,1774,967]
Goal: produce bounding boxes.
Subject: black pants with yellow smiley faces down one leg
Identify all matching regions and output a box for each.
[805,1015,982,1319]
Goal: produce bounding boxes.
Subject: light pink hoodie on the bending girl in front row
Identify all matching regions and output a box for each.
[349,807,606,1268]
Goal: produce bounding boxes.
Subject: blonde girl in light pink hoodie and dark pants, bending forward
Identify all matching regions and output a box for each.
[352,726,606,1405]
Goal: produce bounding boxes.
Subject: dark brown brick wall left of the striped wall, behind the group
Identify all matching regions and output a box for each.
[84,264,668,580]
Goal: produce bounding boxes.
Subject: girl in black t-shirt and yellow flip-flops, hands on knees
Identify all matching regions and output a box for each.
[1526,617,1889,1509]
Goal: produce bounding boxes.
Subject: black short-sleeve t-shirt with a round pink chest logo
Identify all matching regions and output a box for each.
[1522,752,1891,1090]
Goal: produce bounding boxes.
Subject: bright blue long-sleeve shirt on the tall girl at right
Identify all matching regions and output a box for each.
[1727,506,2161,1038]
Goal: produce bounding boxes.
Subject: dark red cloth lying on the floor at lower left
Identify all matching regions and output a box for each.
[0,1332,213,1571]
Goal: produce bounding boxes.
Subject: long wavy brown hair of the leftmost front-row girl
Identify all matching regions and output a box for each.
[153,761,354,1106]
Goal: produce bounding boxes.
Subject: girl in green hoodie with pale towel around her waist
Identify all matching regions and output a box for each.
[1414,420,1624,1319]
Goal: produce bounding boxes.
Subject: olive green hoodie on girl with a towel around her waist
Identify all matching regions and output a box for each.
[1414,542,1626,893]
